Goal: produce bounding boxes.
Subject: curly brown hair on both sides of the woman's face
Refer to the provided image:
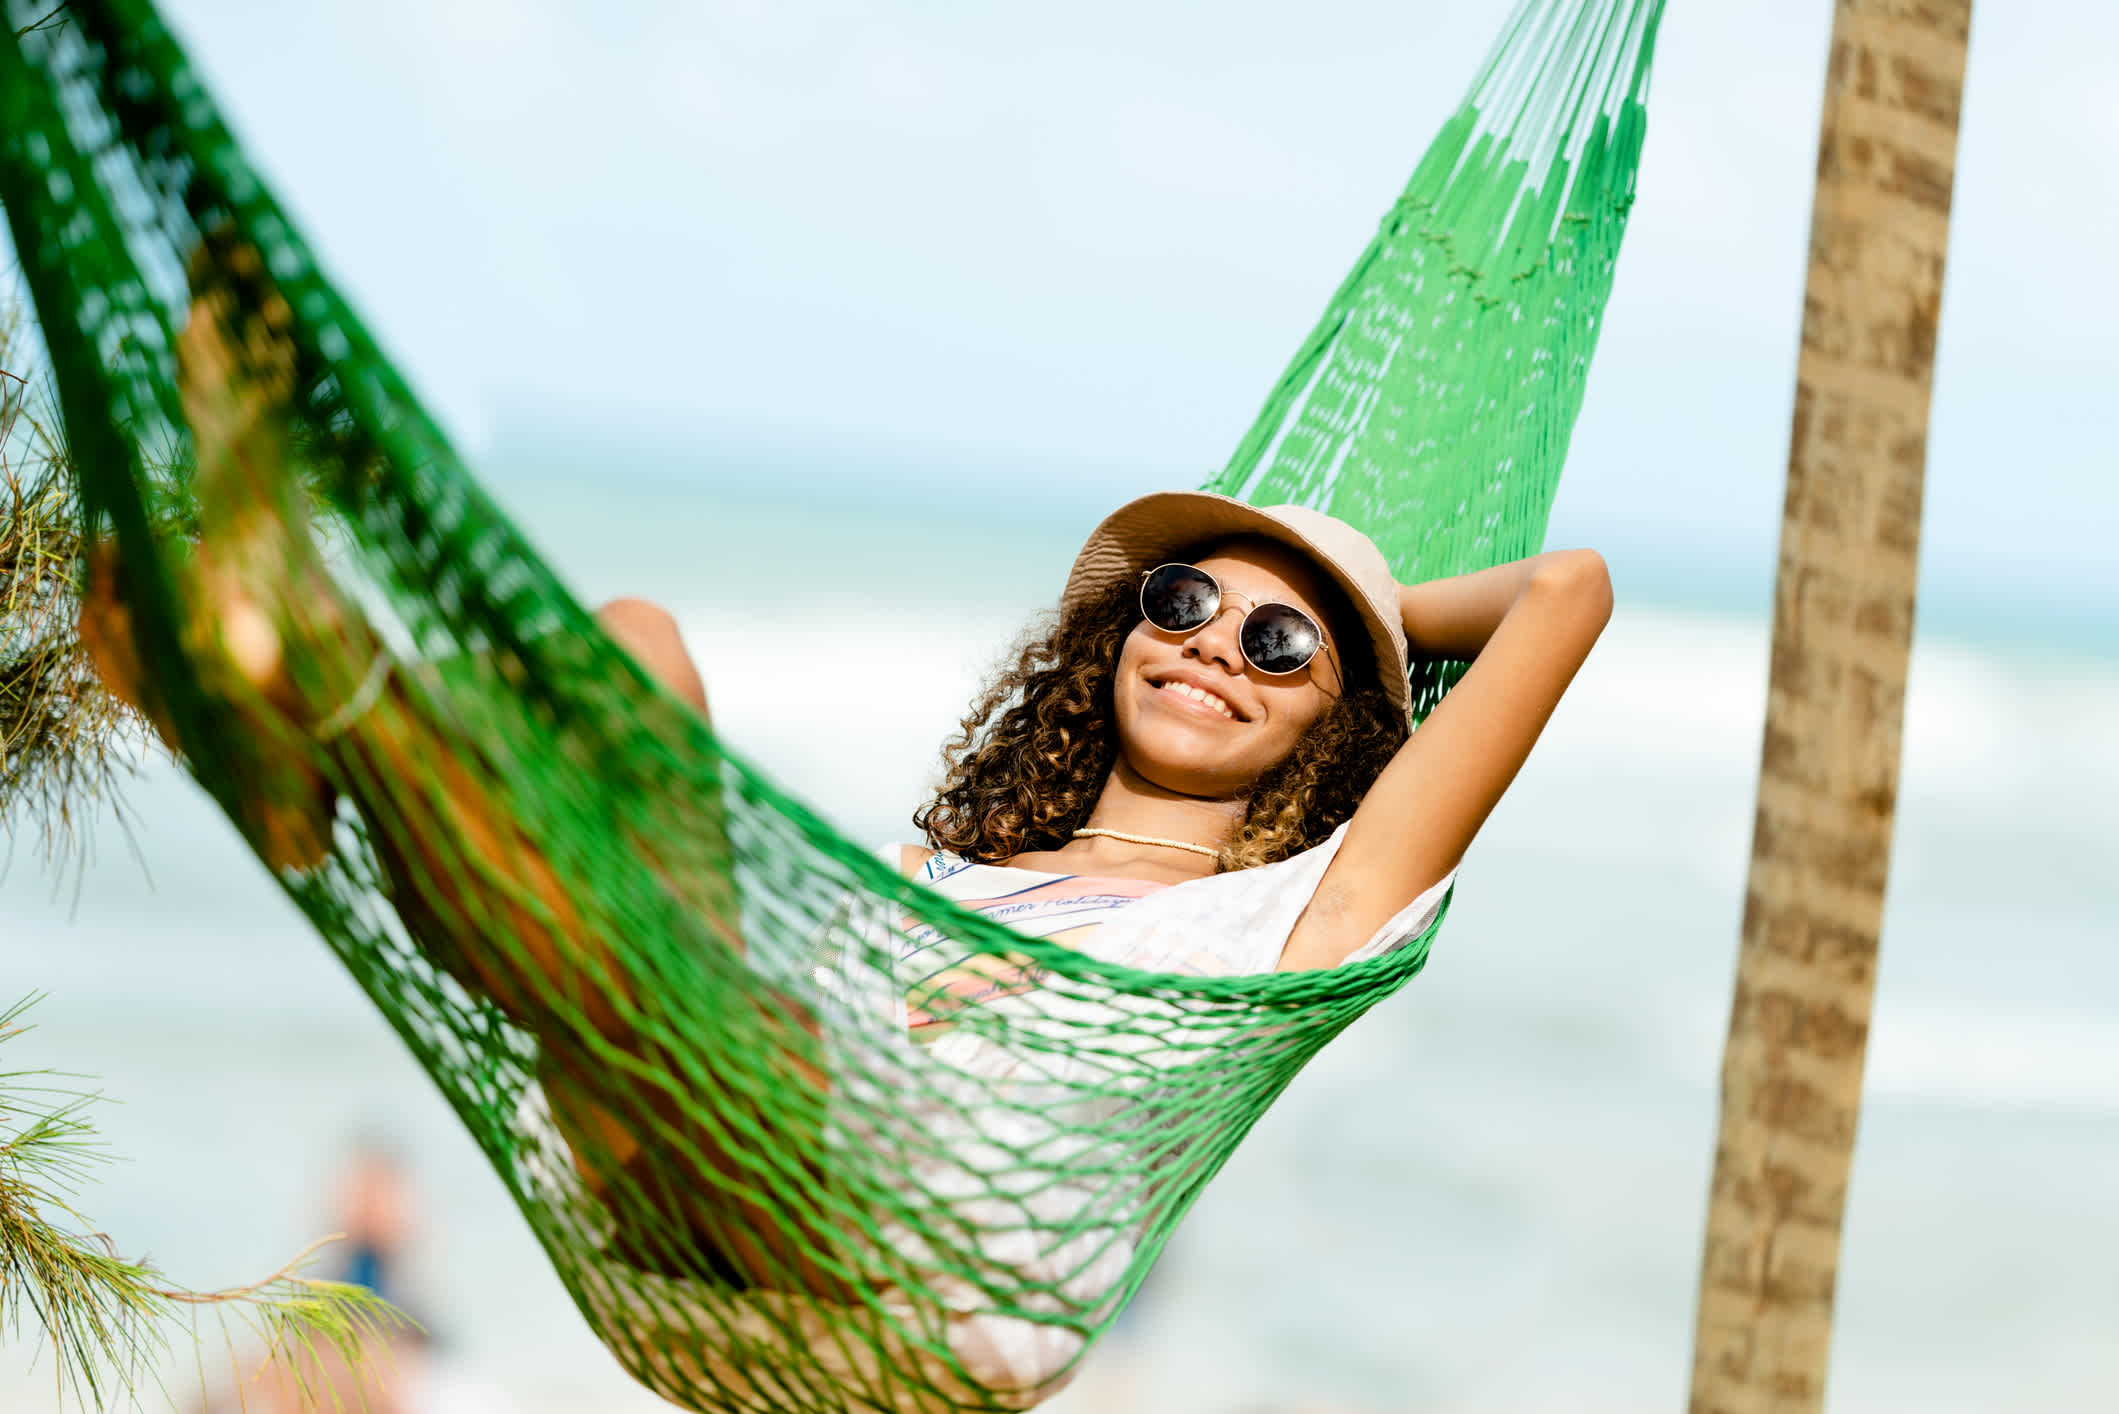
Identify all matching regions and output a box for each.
[913,555,1407,871]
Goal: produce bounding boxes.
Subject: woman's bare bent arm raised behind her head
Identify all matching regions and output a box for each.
[1280,549,1610,969]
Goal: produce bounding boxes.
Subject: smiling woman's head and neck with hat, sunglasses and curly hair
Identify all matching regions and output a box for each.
[918,494,1409,882]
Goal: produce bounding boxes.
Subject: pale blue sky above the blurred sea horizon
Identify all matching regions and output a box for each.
[140,0,2119,640]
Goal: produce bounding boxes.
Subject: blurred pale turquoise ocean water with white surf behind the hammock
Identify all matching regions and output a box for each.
[0,479,2119,1414]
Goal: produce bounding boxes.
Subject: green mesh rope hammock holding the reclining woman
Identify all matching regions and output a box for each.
[0,0,1661,1410]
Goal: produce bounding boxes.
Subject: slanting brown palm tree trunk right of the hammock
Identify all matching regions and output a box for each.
[1691,0,1971,1414]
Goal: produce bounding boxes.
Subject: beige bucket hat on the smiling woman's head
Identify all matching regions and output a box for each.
[1060,492,1413,721]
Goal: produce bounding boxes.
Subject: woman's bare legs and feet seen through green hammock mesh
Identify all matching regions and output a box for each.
[83,271,845,1295]
